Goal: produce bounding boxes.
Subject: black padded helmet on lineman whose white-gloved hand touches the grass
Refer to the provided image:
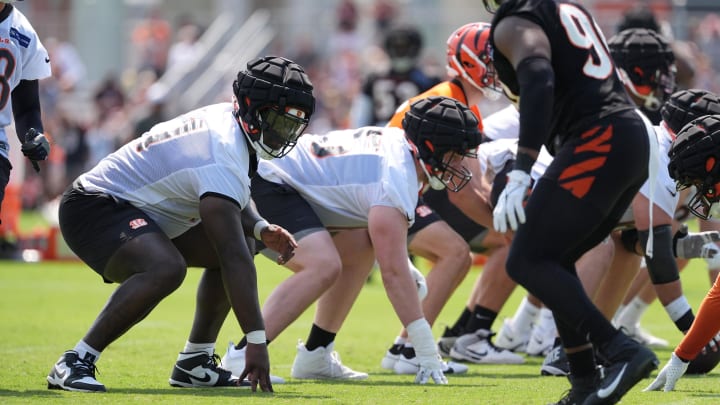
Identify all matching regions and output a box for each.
[402,96,481,191]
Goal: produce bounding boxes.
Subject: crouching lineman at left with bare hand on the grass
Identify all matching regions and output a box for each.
[47,56,315,392]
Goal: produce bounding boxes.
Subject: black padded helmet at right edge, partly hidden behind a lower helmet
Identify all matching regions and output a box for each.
[660,89,720,134]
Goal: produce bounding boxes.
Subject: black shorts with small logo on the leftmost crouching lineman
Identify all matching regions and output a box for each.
[59,182,163,283]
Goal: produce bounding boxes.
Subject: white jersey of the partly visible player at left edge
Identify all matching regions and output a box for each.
[0,4,50,158]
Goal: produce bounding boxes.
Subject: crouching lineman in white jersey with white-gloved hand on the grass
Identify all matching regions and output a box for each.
[222,97,481,384]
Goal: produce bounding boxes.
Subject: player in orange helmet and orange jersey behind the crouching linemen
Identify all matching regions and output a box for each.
[382,22,524,373]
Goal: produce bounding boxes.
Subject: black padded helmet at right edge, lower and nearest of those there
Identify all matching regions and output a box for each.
[668,115,720,219]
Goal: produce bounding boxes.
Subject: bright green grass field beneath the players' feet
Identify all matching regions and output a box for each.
[0,248,720,404]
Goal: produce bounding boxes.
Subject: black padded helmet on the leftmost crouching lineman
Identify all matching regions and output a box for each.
[233,56,315,159]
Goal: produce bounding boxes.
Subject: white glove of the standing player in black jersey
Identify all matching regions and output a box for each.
[493,170,530,233]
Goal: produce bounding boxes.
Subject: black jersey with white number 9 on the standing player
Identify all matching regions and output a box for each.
[490,0,635,150]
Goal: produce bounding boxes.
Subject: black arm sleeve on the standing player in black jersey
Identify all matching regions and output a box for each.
[516,56,555,155]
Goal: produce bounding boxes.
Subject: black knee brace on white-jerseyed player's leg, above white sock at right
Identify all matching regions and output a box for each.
[638,225,680,284]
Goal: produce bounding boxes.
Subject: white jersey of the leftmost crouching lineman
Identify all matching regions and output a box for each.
[79,103,254,238]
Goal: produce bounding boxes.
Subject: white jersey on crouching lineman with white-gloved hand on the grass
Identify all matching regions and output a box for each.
[258,127,422,229]
